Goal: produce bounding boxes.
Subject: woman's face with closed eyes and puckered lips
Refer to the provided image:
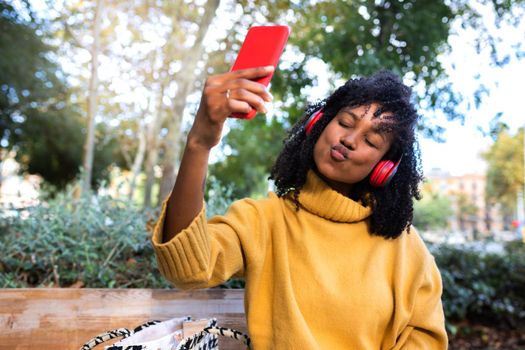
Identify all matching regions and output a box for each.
[314,103,393,193]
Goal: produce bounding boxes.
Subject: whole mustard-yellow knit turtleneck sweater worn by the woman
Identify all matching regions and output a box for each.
[152,172,447,349]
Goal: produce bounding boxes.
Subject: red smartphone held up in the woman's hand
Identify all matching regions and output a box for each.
[231,26,290,119]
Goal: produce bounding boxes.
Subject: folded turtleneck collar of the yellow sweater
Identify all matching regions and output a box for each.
[299,170,372,222]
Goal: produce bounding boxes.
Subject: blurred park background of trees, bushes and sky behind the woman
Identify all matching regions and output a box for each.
[0,0,525,349]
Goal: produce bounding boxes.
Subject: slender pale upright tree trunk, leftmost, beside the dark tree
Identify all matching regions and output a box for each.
[82,0,103,193]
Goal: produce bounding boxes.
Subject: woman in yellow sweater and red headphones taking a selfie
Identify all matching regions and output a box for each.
[152,67,447,349]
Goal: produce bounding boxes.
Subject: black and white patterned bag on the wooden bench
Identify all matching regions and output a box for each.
[80,317,250,350]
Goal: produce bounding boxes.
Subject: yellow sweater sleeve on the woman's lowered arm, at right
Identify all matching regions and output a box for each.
[395,256,448,350]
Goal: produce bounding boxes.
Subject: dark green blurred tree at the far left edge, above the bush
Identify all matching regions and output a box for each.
[0,1,115,189]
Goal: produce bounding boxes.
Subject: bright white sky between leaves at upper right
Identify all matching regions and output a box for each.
[420,4,525,175]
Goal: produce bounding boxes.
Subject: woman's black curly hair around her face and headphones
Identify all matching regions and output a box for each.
[270,71,423,238]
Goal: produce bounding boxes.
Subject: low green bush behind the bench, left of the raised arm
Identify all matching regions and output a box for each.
[0,182,168,288]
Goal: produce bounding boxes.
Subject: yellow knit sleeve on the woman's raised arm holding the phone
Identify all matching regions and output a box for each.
[152,200,266,289]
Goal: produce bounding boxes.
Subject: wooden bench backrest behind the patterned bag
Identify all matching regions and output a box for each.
[0,288,246,350]
